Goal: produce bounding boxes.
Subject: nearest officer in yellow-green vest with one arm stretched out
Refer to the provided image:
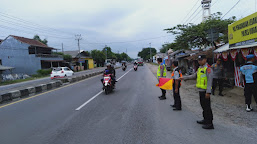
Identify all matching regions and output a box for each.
[180,55,214,129]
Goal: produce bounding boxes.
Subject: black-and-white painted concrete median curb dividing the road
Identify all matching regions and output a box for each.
[0,67,120,103]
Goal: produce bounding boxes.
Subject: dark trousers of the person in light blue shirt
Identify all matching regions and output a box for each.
[244,83,257,105]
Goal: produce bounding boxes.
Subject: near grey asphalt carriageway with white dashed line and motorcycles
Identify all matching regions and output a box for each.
[0,65,254,144]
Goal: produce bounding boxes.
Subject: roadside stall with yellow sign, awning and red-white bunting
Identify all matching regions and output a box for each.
[215,13,257,87]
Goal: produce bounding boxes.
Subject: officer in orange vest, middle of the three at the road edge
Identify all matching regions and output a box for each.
[171,61,182,111]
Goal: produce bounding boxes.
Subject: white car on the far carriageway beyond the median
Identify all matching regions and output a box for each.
[51,67,74,79]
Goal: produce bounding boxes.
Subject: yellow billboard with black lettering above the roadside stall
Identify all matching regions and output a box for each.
[228,12,257,47]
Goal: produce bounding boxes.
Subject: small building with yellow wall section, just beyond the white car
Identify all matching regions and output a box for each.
[64,50,94,70]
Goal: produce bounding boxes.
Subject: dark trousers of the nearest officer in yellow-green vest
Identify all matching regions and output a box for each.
[199,91,213,124]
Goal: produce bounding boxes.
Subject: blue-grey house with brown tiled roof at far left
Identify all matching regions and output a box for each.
[0,35,63,75]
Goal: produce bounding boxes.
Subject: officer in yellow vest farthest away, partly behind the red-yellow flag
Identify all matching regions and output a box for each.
[157,58,166,100]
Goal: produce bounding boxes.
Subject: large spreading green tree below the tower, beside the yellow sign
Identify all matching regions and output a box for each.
[165,12,236,50]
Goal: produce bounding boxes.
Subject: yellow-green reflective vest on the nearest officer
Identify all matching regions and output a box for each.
[196,67,208,89]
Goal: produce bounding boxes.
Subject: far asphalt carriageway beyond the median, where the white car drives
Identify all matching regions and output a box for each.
[0,67,105,91]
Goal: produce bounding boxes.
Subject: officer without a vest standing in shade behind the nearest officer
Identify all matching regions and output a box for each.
[211,59,224,96]
